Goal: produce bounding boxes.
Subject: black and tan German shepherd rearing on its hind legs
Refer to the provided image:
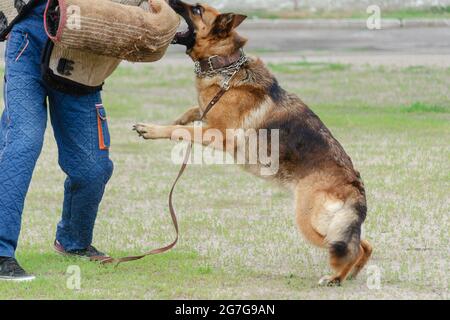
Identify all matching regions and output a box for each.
[134,0,372,286]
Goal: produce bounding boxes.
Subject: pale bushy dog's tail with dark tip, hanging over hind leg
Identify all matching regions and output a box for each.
[326,200,367,262]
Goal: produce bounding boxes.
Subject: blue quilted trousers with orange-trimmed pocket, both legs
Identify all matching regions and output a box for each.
[0,2,113,257]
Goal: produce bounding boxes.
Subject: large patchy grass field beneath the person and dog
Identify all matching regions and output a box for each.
[0,60,450,299]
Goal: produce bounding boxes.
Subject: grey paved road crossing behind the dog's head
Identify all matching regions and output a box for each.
[0,21,450,66]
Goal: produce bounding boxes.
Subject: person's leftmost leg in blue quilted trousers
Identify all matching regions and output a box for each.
[0,19,47,257]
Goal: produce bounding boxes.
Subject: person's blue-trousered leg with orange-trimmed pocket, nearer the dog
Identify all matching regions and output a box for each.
[49,90,113,252]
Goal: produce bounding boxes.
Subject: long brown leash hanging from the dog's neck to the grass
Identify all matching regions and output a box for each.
[101,74,234,267]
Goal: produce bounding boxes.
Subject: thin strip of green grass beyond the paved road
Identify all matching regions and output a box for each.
[241,6,450,19]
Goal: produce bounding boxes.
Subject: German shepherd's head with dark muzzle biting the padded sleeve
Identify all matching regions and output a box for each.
[169,0,247,60]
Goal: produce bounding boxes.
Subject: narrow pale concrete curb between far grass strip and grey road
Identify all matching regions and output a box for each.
[241,19,450,30]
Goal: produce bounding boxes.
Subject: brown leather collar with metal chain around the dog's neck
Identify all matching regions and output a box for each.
[195,49,248,78]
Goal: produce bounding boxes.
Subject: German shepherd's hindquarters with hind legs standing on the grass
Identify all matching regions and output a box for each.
[295,177,367,286]
